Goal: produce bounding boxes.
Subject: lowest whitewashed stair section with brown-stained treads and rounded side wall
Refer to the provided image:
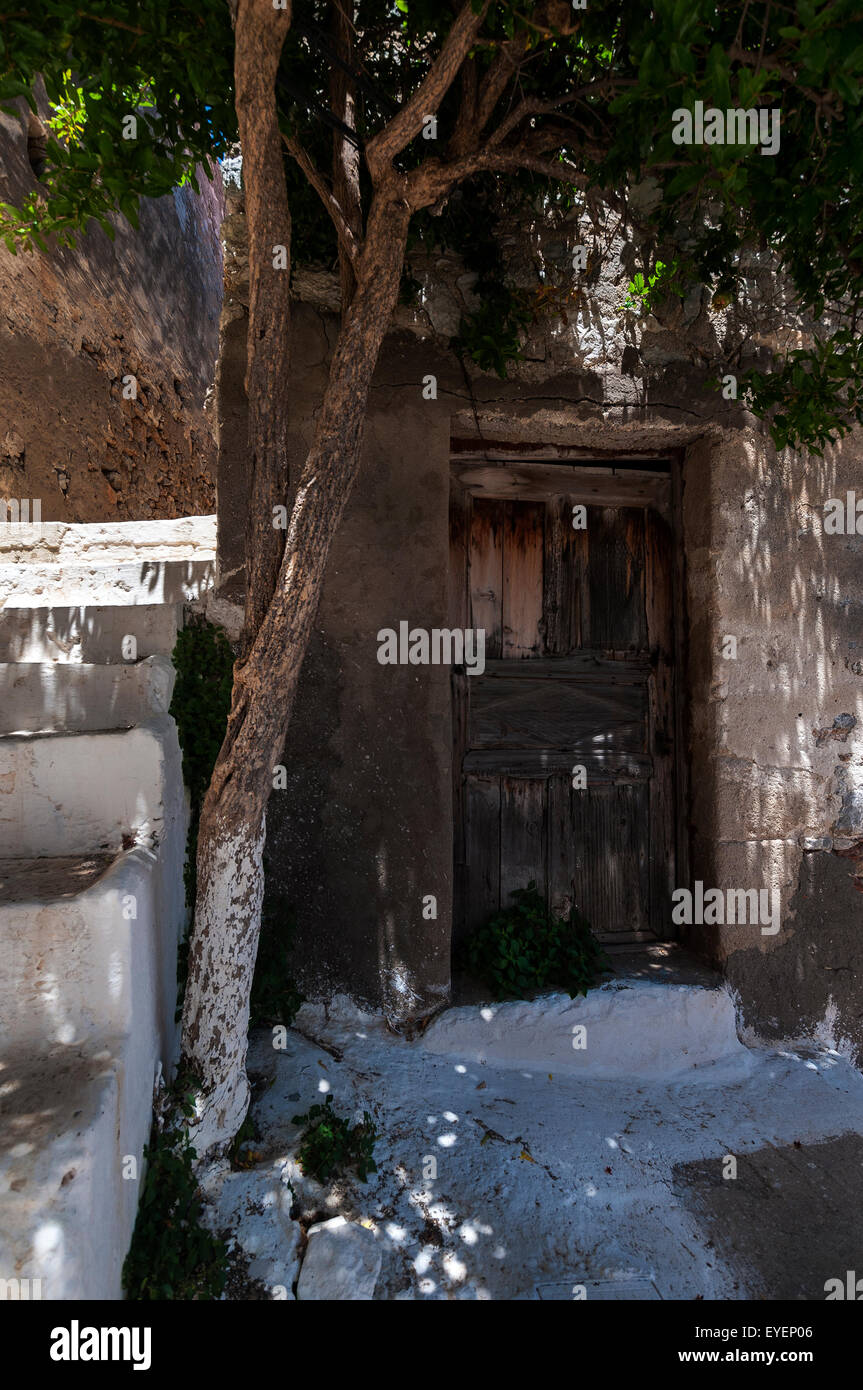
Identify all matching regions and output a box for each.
[0,845,183,1300]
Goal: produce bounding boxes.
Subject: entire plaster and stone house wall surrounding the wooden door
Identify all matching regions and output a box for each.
[220,187,863,1055]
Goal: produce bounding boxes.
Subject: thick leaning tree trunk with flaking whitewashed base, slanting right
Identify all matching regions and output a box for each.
[182,193,410,1154]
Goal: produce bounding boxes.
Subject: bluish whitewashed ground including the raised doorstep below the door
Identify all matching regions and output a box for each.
[204,959,863,1300]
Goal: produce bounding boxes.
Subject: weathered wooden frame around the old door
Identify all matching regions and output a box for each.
[449,442,691,944]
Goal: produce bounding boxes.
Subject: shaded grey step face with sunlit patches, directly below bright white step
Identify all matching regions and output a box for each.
[0,603,182,666]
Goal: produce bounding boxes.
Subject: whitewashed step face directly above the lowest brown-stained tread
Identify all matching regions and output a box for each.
[0,714,185,863]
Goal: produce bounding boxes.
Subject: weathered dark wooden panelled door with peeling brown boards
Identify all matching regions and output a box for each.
[452,464,675,941]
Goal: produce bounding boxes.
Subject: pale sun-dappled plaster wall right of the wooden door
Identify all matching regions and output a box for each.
[685,432,863,1059]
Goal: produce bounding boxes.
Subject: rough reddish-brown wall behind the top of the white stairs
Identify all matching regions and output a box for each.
[0,99,222,521]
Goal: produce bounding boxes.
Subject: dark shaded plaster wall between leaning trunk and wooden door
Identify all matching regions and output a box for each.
[267,307,452,1017]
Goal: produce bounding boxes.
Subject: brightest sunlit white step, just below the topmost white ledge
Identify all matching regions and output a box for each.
[0,556,215,609]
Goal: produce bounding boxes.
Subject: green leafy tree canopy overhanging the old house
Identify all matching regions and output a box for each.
[0,0,863,452]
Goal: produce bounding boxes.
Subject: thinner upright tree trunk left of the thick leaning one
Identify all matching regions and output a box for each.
[175,0,290,1134]
